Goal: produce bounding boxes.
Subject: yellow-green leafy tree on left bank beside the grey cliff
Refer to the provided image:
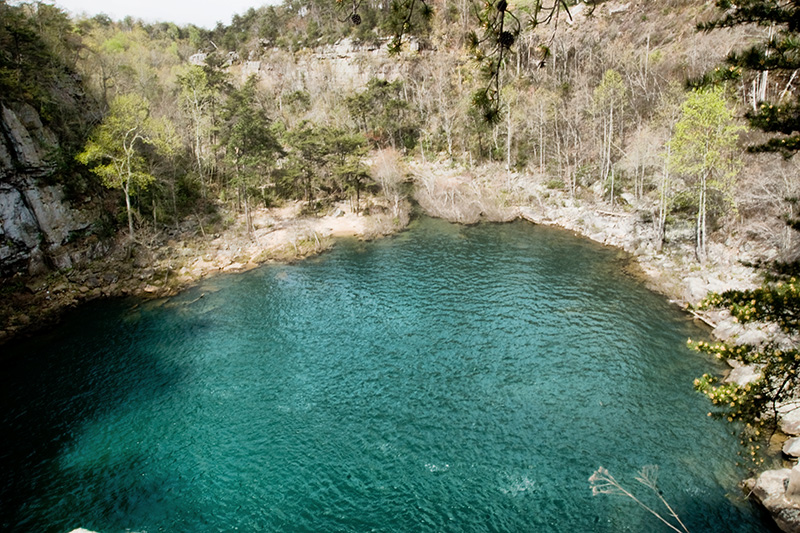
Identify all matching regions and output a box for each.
[76,94,176,240]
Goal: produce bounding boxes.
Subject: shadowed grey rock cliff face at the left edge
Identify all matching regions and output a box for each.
[0,104,93,275]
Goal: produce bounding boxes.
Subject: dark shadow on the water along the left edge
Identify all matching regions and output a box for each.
[0,300,194,531]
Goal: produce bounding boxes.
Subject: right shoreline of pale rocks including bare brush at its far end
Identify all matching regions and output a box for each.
[417,157,800,533]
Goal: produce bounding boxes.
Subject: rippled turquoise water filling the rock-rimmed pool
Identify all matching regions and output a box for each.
[0,220,769,533]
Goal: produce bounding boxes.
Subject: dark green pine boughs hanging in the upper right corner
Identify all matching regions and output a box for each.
[699,0,800,157]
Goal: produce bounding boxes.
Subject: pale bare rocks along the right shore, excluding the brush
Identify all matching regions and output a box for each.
[520,193,800,533]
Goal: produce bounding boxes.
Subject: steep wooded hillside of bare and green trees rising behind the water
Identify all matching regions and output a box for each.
[0,0,797,324]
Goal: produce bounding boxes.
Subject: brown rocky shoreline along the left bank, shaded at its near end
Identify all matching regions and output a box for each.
[0,202,408,344]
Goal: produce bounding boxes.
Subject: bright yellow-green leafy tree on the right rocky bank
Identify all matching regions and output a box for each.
[668,87,742,261]
